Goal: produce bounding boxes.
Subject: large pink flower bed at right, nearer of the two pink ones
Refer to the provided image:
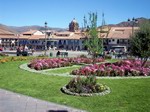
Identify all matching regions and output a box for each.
[71,60,150,76]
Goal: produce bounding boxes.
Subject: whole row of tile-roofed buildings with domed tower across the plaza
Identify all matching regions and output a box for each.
[0,20,138,50]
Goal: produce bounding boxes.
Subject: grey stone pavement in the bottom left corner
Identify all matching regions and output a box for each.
[0,89,85,112]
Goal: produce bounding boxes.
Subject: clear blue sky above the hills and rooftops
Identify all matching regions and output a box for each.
[0,0,150,28]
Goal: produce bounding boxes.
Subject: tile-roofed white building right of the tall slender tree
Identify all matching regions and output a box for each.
[104,27,138,50]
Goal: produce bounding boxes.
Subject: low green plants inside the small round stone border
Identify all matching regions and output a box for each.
[62,76,107,93]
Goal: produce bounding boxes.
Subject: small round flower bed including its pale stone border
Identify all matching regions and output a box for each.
[61,76,110,96]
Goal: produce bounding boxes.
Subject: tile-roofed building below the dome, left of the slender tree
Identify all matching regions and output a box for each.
[50,31,84,50]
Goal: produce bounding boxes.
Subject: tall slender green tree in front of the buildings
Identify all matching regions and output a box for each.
[84,13,103,63]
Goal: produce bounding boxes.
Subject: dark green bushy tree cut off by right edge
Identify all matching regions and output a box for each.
[130,21,150,66]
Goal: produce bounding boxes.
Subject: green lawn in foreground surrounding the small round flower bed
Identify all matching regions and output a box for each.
[0,61,150,112]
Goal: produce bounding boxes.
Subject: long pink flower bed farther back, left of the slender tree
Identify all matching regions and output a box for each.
[28,58,104,70]
